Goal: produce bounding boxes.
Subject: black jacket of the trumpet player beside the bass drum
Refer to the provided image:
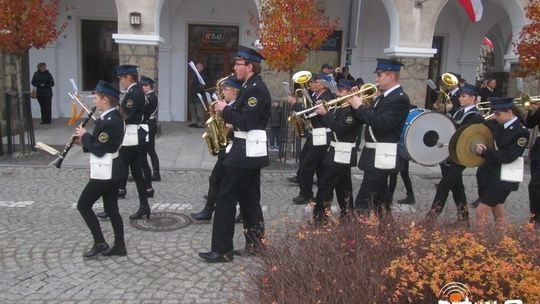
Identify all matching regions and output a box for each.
[355,86,410,172]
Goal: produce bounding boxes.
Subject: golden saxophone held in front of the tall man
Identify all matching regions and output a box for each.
[202,74,233,156]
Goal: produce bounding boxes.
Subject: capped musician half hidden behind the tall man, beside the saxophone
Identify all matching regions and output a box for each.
[190,76,242,221]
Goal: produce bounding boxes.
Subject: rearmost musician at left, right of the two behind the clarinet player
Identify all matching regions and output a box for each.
[139,76,161,182]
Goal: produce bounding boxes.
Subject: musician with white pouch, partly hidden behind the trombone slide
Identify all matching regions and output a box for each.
[288,74,335,204]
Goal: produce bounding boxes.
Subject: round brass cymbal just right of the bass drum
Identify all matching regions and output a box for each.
[455,124,493,167]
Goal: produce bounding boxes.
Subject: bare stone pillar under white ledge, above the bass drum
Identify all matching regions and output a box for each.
[398,58,429,108]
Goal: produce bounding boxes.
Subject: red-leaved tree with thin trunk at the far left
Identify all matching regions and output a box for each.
[0,0,66,154]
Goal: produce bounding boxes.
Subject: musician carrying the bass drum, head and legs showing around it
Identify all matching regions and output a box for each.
[426,84,484,226]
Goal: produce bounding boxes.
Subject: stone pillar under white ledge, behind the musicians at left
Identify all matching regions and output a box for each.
[118,44,159,89]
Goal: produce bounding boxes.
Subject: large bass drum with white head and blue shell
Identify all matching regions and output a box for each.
[399,109,456,166]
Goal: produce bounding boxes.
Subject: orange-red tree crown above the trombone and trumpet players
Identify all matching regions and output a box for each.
[252,0,337,72]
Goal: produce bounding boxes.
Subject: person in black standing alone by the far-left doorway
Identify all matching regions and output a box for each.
[32,62,54,125]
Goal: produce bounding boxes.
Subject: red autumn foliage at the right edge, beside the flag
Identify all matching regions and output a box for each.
[516,0,540,77]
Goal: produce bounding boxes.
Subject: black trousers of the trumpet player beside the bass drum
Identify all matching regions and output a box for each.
[354,171,392,215]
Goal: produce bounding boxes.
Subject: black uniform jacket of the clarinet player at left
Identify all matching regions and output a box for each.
[81,109,125,181]
